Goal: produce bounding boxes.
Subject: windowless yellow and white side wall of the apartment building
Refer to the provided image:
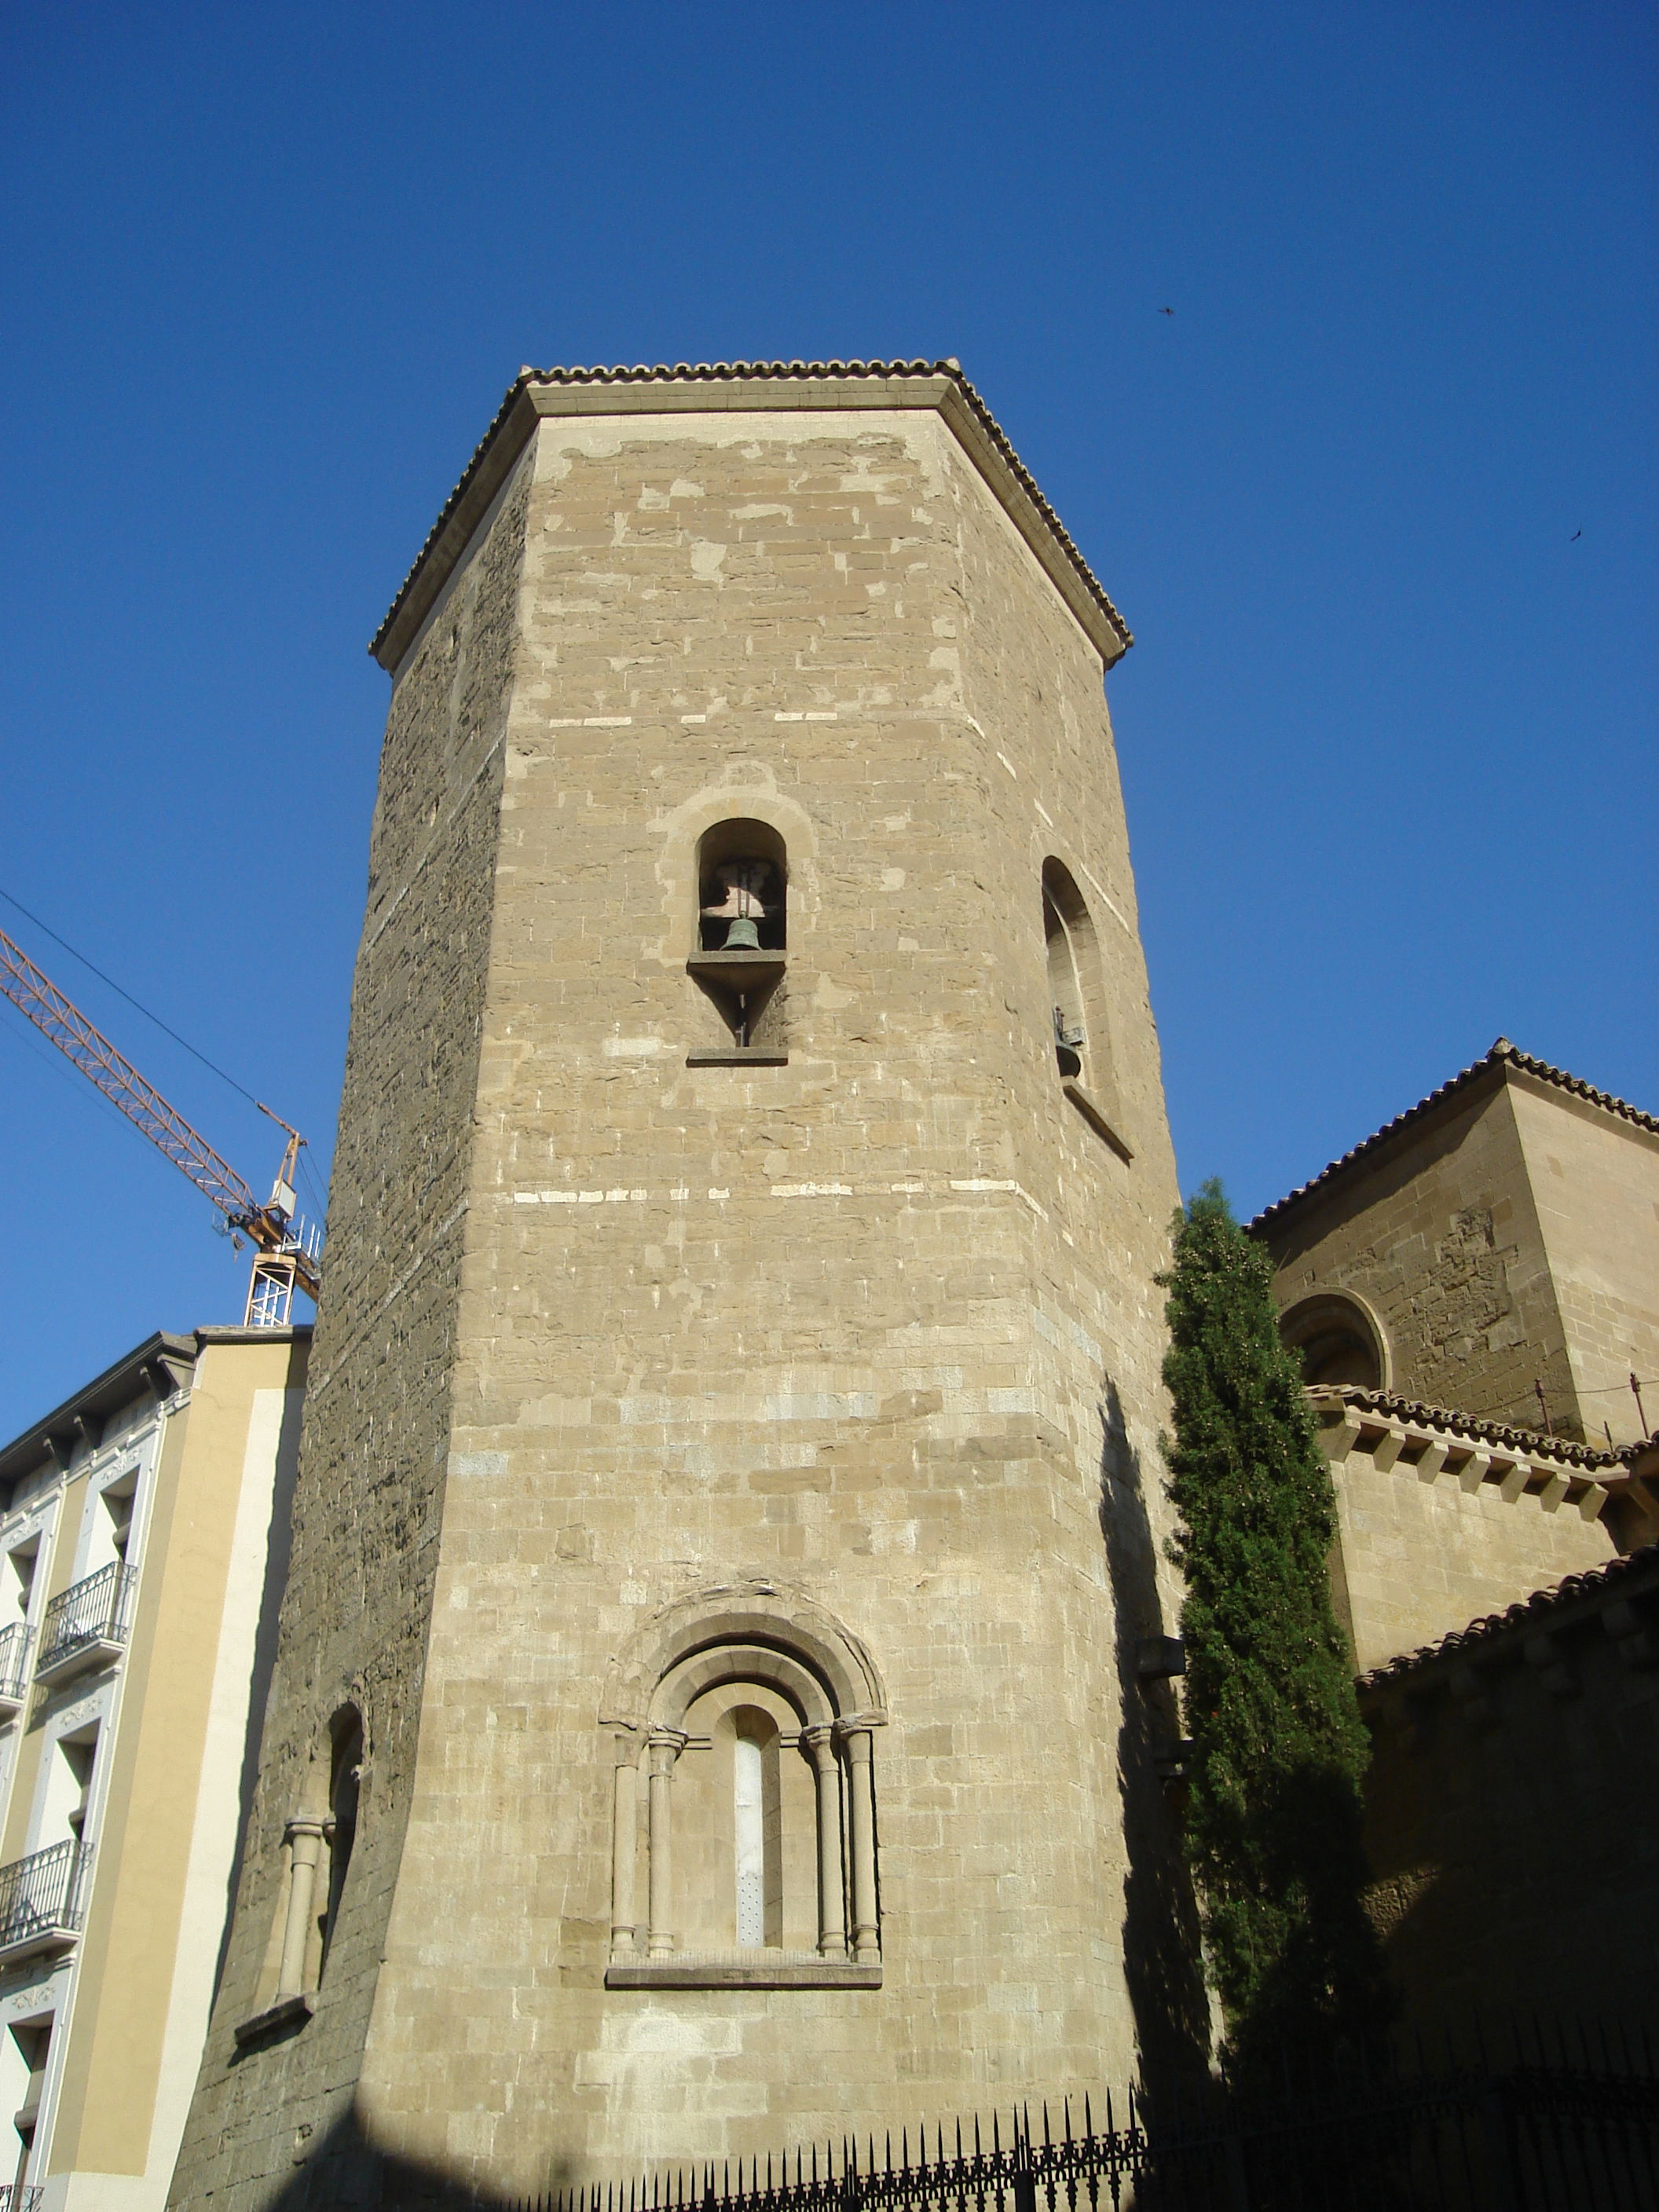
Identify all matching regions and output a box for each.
[44,1331,306,2212]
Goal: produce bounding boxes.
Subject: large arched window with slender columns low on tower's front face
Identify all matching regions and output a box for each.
[602,1584,887,1989]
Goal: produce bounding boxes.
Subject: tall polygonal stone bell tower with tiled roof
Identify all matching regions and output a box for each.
[174,363,1177,2212]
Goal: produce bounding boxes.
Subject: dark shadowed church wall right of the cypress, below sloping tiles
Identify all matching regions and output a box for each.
[1361,1551,1659,2038]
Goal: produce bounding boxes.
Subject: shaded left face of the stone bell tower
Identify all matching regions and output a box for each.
[173,453,529,2212]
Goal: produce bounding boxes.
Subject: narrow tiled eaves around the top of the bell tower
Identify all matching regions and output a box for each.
[369,358,1135,670]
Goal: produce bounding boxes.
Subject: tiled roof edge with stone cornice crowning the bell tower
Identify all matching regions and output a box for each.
[369,361,1135,668]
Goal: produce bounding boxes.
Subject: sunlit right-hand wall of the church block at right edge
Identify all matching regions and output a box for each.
[1511,1073,1659,1445]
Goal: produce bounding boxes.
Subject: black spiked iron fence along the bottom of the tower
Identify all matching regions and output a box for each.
[506,2031,1659,2212]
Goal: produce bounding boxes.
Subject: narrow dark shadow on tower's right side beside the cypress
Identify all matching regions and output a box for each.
[1100,1376,1210,2095]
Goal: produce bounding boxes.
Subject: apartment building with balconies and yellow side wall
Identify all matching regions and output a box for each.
[0,1328,309,2212]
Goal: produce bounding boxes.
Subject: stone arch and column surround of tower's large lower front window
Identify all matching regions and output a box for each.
[599,1581,887,1989]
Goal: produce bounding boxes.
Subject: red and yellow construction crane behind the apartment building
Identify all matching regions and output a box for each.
[0,929,320,1329]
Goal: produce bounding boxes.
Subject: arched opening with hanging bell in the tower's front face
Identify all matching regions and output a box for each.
[688,816,789,1055]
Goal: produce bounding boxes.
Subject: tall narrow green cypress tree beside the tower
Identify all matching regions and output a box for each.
[1161,1184,1389,2079]
